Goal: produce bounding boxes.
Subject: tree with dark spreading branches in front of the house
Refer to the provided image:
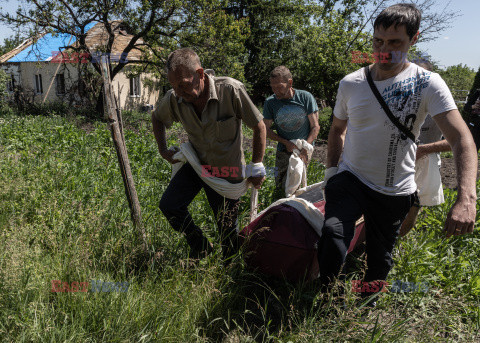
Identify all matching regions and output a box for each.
[0,0,248,110]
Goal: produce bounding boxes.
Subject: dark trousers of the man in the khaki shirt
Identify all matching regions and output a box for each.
[160,163,239,257]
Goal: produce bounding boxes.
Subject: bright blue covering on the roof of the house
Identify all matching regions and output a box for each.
[6,22,96,62]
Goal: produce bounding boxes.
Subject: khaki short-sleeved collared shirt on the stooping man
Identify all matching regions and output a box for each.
[153,74,263,182]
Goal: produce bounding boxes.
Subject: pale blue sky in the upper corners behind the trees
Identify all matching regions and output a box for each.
[0,0,480,71]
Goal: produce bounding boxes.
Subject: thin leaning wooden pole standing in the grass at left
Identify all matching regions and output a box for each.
[100,57,148,253]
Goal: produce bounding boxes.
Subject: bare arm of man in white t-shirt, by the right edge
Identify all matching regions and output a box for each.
[433,110,478,237]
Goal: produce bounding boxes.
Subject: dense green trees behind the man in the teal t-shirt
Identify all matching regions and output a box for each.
[225,0,457,105]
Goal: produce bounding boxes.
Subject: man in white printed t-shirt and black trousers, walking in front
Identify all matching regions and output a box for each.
[319,4,477,302]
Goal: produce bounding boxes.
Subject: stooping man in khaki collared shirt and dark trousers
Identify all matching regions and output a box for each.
[152,48,266,258]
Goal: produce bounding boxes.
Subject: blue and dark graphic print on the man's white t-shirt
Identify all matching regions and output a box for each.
[380,72,431,187]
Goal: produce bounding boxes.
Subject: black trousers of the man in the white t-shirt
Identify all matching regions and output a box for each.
[319,171,415,286]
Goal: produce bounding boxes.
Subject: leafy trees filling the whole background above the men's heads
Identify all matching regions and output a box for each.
[0,0,458,109]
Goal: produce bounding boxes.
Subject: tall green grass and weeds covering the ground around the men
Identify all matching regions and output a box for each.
[0,113,480,342]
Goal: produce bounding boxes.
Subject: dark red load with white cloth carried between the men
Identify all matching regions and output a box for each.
[239,182,365,282]
